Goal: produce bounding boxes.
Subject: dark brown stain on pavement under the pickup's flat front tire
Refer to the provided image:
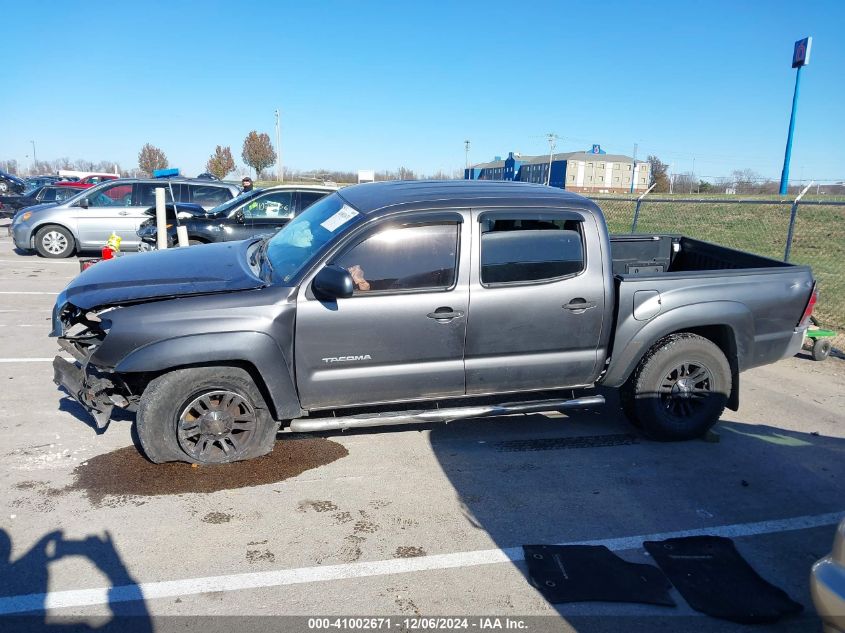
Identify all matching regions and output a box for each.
[64,437,349,504]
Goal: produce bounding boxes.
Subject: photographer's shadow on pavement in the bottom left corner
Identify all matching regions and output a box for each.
[0,529,153,633]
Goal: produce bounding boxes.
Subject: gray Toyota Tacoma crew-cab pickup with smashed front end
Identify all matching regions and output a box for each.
[52,181,816,463]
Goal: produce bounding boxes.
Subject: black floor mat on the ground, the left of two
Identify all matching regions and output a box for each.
[522,545,675,607]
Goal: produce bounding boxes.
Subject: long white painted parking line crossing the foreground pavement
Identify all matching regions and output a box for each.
[0,512,845,615]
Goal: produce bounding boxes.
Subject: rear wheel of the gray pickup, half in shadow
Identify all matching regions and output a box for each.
[622,333,732,441]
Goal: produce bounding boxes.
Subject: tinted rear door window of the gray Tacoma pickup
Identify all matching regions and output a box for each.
[480,213,586,284]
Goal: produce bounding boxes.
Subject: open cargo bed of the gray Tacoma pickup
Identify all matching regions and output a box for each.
[604,235,813,386]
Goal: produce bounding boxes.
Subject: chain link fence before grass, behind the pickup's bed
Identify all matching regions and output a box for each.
[592,196,845,350]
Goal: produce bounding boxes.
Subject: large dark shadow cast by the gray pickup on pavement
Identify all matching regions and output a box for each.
[430,392,845,633]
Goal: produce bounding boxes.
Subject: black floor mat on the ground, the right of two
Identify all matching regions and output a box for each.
[643,536,804,624]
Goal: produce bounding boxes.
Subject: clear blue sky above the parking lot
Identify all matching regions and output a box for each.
[0,0,845,180]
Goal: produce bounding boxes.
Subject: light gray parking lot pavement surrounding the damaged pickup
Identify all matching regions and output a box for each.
[0,228,845,631]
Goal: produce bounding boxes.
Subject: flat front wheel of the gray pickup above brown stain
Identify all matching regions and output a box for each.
[136,366,280,464]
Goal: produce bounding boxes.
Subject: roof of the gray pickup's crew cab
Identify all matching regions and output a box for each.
[339,180,593,214]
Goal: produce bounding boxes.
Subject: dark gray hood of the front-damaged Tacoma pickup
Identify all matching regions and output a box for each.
[61,240,267,310]
